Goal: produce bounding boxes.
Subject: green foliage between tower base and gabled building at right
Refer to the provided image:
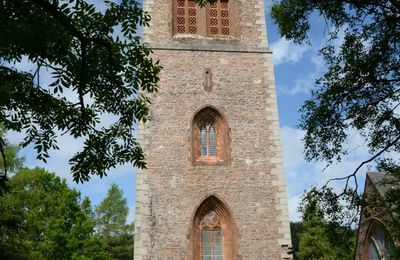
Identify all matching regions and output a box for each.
[296,188,360,260]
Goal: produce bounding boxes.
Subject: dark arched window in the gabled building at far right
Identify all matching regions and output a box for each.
[366,221,394,260]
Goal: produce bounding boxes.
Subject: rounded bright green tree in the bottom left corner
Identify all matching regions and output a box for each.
[0,168,110,259]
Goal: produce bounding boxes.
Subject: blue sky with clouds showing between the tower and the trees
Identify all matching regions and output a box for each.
[8,0,368,223]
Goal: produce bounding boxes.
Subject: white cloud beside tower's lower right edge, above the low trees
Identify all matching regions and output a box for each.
[281,127,374,221]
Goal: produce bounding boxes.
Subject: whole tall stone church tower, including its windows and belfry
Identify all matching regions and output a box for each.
[135,0,290,260]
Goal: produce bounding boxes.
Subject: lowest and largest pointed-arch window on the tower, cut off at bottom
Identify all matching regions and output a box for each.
[191,196,237,260]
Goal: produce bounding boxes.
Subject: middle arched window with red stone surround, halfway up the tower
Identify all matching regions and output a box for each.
[192,107,230,163]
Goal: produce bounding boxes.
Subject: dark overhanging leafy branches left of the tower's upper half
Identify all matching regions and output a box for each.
[0,0,161,185]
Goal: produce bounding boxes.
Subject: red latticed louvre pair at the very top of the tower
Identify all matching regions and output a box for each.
[173,0,233,36]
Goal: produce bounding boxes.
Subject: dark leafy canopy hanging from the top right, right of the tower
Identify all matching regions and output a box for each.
[272,0,400,241]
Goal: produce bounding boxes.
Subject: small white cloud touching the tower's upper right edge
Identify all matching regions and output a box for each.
[271,38,311,66]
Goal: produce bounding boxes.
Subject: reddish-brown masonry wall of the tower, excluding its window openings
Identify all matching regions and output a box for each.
[135,0,290,260]
